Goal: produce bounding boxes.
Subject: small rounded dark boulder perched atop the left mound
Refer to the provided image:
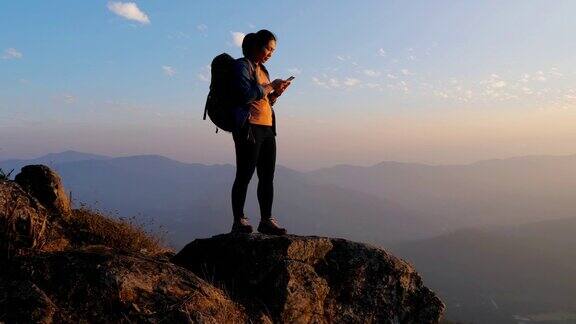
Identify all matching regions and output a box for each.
[14,164,71,218]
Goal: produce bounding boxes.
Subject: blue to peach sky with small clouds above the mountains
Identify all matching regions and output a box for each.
[0,0,576,168]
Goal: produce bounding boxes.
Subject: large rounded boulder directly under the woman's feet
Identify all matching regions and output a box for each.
[172,234,444,323]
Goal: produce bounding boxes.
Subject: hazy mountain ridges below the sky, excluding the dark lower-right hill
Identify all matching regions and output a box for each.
[0,151,576,247]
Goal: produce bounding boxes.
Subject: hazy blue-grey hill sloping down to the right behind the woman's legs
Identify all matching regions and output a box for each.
[0,155,442,246]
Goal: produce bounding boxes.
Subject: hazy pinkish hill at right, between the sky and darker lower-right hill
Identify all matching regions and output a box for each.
[306,155,576,229]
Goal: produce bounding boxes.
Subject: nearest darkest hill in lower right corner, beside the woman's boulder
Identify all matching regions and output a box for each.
[392,218,576,323]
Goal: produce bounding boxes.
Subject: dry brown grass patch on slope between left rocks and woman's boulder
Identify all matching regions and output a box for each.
[63,206,170,254]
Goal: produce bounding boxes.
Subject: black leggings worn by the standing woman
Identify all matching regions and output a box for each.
[232,123,276,219]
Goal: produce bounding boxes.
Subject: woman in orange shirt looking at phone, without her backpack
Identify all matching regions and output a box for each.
[232,29,290,235]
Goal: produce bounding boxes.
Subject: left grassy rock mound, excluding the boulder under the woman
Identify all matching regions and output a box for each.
[0,167,247,324]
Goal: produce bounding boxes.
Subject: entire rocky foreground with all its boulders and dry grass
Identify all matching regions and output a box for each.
[0,166,444,323]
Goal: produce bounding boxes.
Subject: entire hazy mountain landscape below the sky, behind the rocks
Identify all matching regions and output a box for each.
[0,151,576,324]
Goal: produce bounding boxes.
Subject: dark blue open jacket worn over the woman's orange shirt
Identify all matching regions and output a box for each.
[234,57,276,135]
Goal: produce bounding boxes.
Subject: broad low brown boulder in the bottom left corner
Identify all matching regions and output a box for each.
[0,246,246,323]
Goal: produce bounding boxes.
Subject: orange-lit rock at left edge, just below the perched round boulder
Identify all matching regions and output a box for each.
[0,181,48,259]
